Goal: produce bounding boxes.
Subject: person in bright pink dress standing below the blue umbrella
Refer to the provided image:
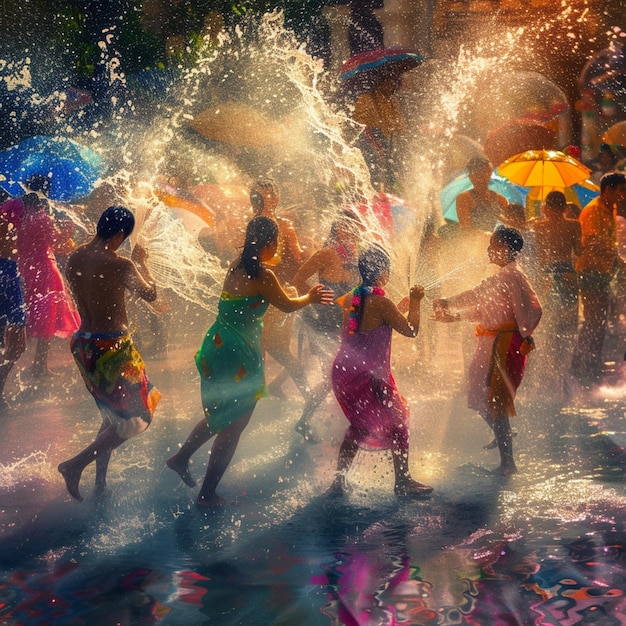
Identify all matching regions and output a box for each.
[18,177,80,378]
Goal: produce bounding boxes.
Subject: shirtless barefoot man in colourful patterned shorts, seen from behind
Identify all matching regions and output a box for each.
[58,206,161,500]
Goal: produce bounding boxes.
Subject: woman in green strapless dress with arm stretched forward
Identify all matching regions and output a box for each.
[167,217,333,508]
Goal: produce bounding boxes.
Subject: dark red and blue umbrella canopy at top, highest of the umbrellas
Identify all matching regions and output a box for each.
[339,48,426,95]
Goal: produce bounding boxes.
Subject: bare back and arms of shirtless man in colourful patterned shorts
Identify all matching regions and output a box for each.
[66,237,156,333]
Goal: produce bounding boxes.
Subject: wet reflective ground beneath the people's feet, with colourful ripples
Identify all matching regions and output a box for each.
[0,316,626,626]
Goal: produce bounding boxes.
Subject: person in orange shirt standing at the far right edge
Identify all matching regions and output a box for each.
[572,172,626,386]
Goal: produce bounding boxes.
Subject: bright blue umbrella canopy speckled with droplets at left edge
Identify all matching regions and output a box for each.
[0,135,103,202]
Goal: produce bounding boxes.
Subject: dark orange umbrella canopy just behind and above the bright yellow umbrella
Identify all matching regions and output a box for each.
[483,122,557,165]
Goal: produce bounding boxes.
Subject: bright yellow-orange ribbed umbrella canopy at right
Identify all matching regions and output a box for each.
[497,150,591,188]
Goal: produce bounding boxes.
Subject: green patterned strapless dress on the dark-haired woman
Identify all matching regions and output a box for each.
[196,291,269,433]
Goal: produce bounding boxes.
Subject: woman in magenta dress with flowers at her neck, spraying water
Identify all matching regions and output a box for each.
[329,247,433,496]
